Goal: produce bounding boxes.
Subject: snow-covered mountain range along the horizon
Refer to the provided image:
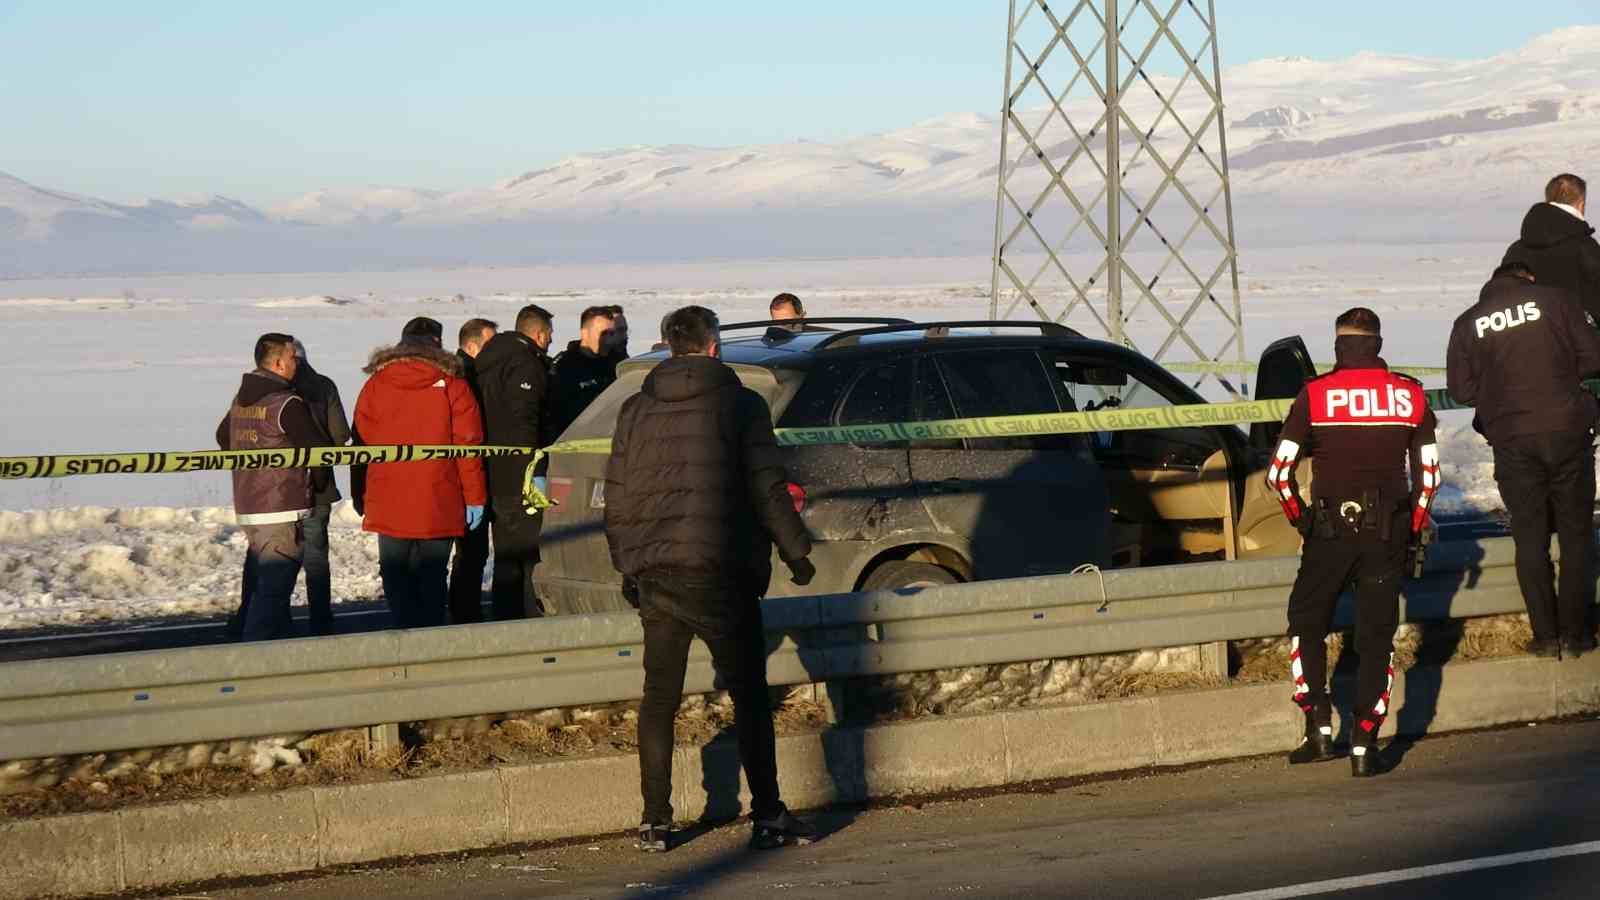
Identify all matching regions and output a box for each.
[0,26,1600,275]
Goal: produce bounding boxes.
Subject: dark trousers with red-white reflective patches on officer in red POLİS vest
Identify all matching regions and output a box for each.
[1290,509,1411,746]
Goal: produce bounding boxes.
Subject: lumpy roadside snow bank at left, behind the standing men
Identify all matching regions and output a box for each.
[0,503,382,629]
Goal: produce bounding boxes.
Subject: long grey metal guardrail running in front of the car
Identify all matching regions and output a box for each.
[0,538,1523,761]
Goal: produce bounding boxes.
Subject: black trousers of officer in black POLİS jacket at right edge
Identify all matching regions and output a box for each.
[1494,431,1595,641]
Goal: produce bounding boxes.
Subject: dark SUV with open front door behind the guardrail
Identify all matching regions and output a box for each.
[536,319,1309,613]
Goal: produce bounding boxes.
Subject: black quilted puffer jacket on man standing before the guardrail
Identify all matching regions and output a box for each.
[605,356,811,596]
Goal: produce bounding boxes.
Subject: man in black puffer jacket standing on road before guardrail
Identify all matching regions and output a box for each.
[605,306,816,852]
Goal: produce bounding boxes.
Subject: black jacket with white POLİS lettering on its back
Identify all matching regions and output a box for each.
[1445,272,1600,444]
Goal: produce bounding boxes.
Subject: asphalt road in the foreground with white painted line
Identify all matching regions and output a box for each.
[170,721,1600,900]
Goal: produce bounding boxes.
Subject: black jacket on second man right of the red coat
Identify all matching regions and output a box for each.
[475,331,550,499]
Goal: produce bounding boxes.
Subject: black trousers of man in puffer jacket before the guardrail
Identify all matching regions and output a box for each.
[638,577,784,825]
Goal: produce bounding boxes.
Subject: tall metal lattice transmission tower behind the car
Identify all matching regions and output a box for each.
[989,0,1246,396]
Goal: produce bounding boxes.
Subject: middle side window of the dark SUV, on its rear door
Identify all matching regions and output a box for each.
[936,349,1088,453]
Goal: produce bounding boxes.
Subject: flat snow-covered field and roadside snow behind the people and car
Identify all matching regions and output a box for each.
[0,245,1504,628]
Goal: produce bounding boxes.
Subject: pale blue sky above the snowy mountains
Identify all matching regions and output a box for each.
[0,0,1600,205]
